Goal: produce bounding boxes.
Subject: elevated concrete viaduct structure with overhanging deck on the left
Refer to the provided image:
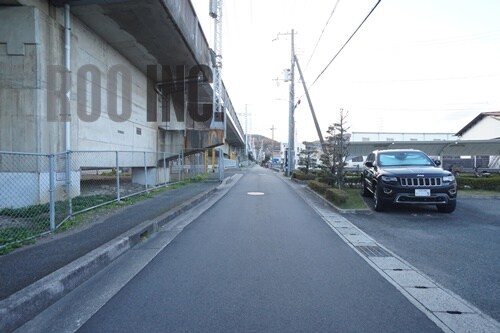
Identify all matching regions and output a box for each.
[0,0,244,206]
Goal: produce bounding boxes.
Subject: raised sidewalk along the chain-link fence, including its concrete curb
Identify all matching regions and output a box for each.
[0,174,240,331]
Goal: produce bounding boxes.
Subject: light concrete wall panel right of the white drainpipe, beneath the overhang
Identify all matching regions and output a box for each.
[71,11,158,151]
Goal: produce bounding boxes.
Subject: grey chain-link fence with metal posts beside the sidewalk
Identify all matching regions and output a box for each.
[0,151,225,249]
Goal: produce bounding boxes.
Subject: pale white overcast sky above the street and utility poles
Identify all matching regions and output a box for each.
[192,0,500,142]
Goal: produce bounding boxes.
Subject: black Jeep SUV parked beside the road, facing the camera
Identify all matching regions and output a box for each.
[361,149,457,213]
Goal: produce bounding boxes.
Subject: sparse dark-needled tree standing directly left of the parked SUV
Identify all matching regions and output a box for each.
[321,109,350,188]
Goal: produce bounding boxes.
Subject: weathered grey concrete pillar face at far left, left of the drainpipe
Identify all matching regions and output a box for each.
[0,7,46,152]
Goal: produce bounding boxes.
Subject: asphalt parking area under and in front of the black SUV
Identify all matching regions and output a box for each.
[345,194,500,321]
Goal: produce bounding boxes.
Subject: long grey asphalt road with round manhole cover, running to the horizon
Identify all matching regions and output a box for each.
[22,167,441,332]
